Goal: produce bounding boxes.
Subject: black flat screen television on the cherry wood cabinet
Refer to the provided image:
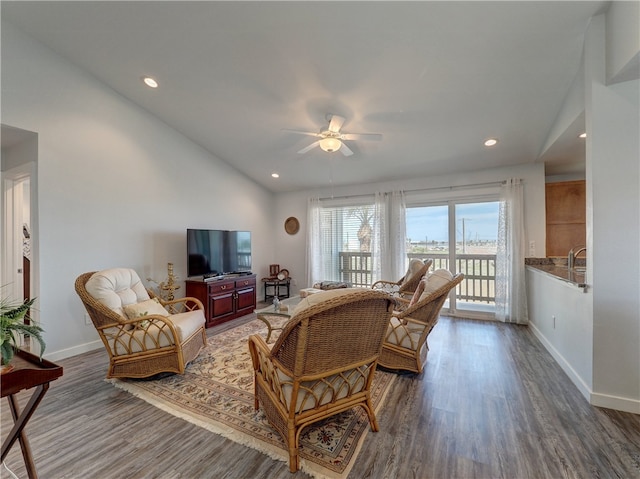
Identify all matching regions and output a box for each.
[187,229,251,276]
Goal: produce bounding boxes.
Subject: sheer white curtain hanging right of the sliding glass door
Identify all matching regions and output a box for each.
[496,178,529,324]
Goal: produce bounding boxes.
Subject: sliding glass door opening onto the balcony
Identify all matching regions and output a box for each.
[406,198,499,317]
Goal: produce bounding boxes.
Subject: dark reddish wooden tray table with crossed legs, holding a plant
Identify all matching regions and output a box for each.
[0,349,62,479]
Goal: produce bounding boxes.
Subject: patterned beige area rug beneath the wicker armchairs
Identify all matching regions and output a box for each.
[108,319,395,478]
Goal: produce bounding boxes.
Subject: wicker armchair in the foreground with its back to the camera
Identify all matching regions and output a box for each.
[249,288,393,472]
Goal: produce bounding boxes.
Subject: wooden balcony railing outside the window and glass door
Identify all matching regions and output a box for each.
[339,252,496,305]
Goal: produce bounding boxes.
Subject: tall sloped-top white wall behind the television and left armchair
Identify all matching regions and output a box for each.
[2,23,273,359]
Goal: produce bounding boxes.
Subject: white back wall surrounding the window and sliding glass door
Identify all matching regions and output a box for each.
[274,164,545,291]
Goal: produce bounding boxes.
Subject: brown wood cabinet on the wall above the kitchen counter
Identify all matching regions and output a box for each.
[545,180,587,257]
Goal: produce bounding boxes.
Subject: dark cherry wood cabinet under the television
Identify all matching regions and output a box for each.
[186,274,256,328]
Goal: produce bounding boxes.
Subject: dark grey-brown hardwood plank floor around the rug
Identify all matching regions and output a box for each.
[0,317,640,479]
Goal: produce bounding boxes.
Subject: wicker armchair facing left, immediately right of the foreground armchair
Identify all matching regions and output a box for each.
[378,273,464,373]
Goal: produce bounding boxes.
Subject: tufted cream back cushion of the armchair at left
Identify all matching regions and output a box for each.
[85,268,149,316]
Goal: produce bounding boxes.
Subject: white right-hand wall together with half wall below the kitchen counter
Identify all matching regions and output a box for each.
[528,12,640,413]
